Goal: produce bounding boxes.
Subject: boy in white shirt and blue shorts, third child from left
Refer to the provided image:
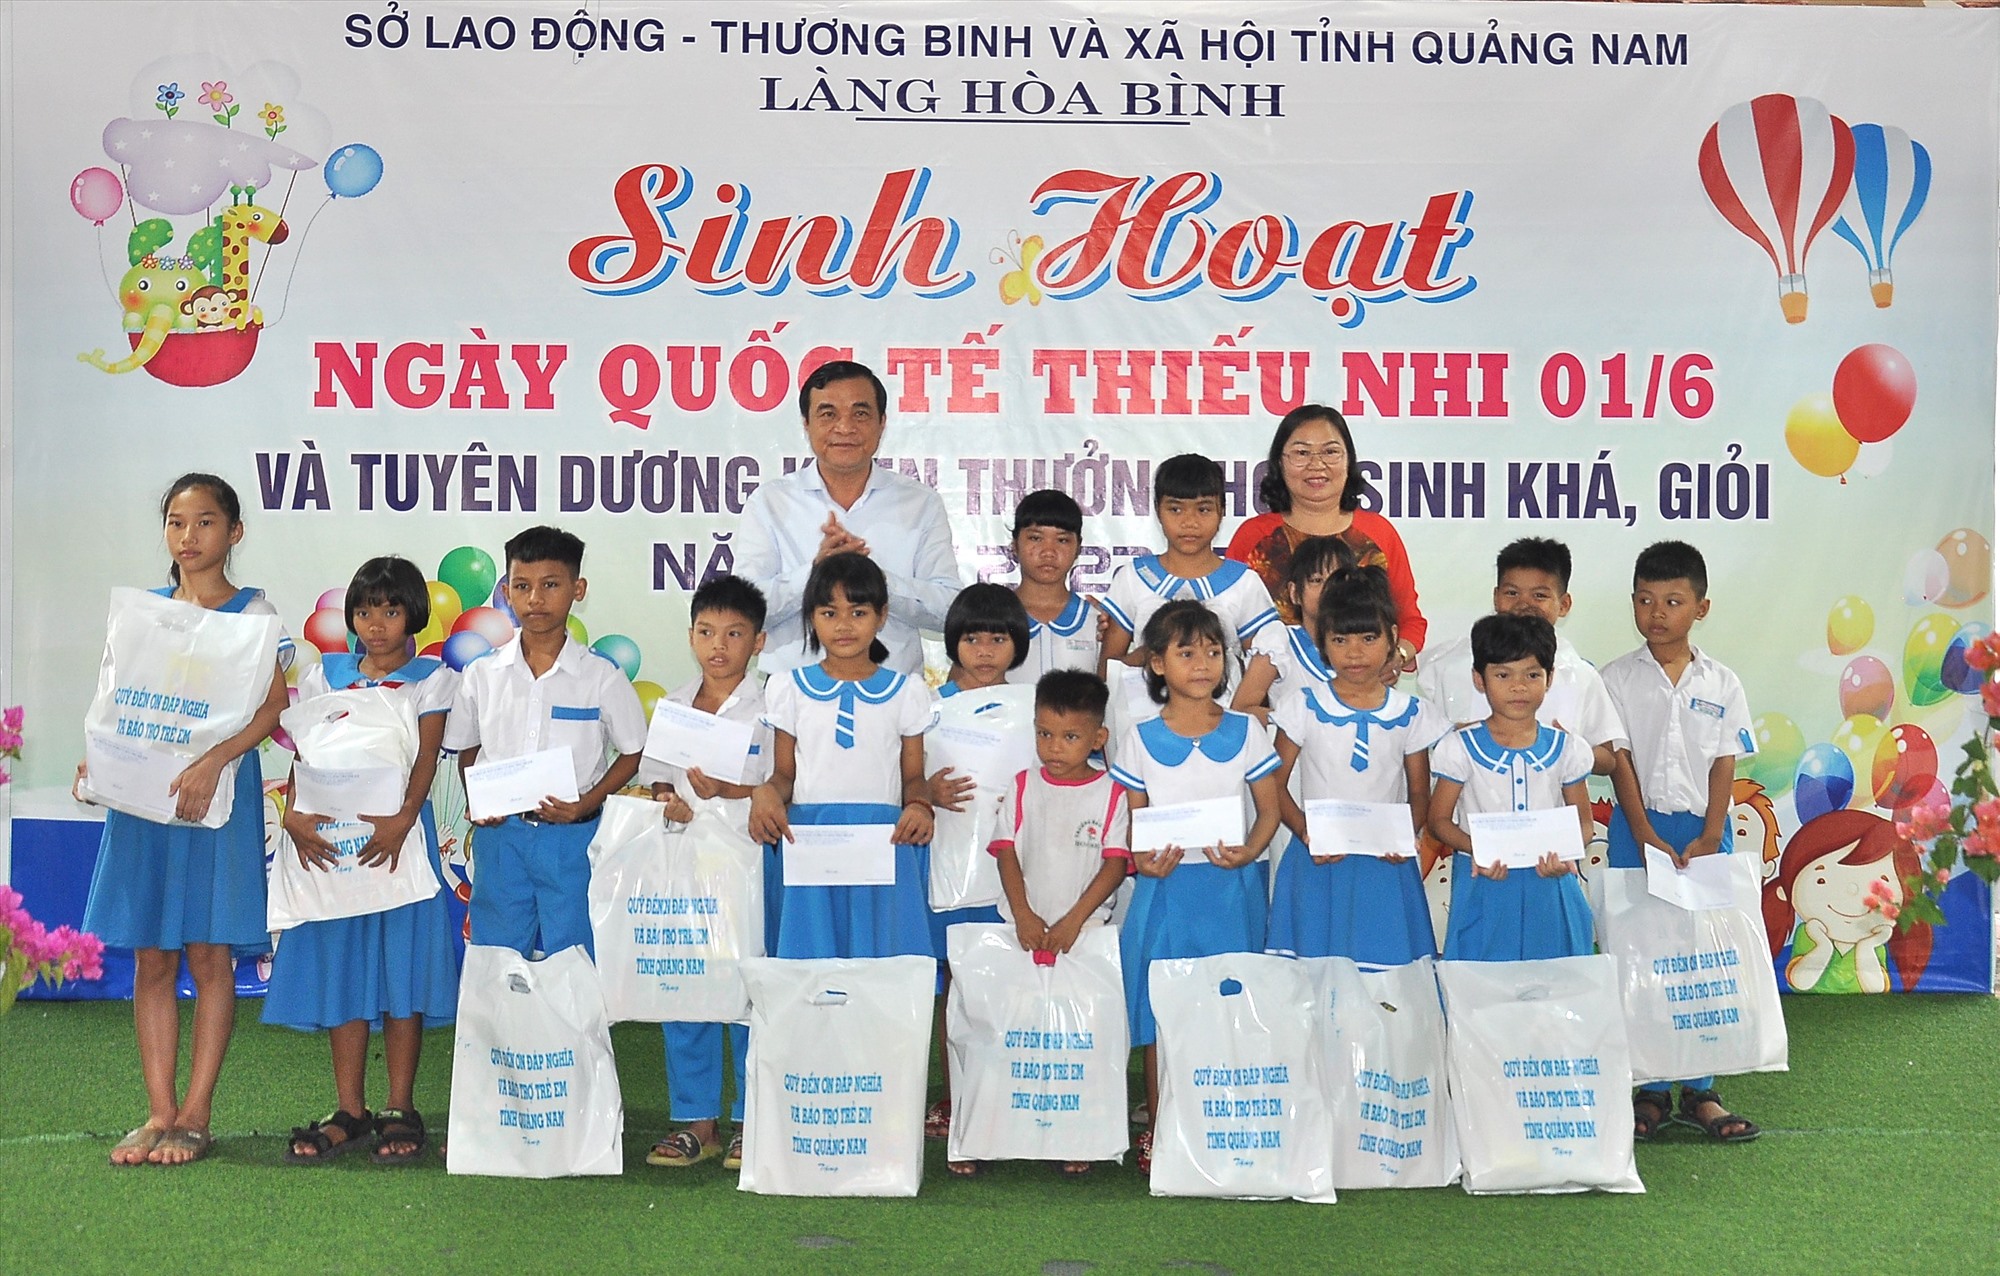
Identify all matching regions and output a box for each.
[444,526,646,956]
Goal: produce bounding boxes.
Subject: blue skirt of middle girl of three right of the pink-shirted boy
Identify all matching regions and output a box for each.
[1264,844,1438,966]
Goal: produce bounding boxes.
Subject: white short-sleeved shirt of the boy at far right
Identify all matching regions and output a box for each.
[1604,646,1756,814]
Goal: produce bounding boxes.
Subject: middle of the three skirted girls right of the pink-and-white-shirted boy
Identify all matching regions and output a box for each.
[1266,566,1450,966]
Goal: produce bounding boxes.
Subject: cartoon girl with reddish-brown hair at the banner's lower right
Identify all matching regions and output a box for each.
[1764,810,1930,992]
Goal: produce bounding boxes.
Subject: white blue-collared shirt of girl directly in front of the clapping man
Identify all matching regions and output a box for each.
[764,664,938,806]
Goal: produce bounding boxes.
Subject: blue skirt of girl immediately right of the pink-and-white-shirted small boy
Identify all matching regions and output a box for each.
[1118,860,1268,1046]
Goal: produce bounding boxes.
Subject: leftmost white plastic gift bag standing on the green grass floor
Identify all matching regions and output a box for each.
[444,944,624,1178]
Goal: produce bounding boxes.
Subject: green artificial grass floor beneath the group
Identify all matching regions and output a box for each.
[0,996,2000,1276]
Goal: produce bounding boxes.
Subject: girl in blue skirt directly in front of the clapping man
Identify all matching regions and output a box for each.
[750,554,936,958]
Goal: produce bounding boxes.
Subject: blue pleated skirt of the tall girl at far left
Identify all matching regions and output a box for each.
[84,750,270,958]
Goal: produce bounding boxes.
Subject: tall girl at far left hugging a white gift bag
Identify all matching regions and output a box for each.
[76,474,292,1166]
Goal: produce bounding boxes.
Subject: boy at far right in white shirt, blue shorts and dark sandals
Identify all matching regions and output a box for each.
[1604,540,1762,1144]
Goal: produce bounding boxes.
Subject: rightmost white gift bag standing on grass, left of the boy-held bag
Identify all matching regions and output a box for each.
[1438,954,1646,1194]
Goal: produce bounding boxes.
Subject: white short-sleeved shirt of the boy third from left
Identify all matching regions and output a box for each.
[444,636,646,792]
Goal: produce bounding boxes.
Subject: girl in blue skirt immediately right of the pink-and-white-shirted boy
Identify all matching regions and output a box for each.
[1112,598,1278,1174]
